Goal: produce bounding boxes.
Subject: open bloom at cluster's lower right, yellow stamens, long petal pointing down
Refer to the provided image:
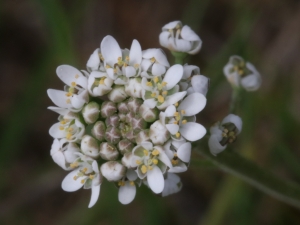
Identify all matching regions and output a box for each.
[132,142,172,194]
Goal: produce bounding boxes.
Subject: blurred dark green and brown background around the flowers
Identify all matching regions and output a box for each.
[0,0,300,225]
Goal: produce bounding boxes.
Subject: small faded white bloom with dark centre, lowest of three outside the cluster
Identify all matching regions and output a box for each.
[208,114,243,156]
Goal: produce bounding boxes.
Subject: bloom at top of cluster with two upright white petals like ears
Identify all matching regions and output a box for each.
[100,35,142,84]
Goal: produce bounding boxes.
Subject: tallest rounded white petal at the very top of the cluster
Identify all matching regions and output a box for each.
[101,35,122,66]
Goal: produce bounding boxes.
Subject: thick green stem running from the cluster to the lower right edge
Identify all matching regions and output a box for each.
[194,145,300,209]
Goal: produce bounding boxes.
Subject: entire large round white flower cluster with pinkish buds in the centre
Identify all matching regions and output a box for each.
[48,34,208,207]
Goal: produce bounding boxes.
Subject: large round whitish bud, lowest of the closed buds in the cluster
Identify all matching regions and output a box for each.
[100,161,126,181]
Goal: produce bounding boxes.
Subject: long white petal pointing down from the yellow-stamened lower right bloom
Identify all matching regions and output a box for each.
[147,166,164,194]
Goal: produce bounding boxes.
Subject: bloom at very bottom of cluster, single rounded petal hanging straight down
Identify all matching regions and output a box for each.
[118,169,138,205]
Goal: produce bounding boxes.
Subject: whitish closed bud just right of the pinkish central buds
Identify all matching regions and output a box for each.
[149,120,170,145]
